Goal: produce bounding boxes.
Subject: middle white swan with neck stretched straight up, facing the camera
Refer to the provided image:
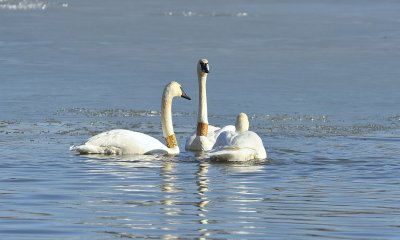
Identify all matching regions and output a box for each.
[185,59,235,151]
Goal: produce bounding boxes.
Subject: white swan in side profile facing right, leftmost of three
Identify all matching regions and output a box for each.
[71,81,190,155]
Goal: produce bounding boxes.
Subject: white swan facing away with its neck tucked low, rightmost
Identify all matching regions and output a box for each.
[206,113,267,161]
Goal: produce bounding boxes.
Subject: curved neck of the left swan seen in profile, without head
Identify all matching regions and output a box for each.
[161,91,177,148]
